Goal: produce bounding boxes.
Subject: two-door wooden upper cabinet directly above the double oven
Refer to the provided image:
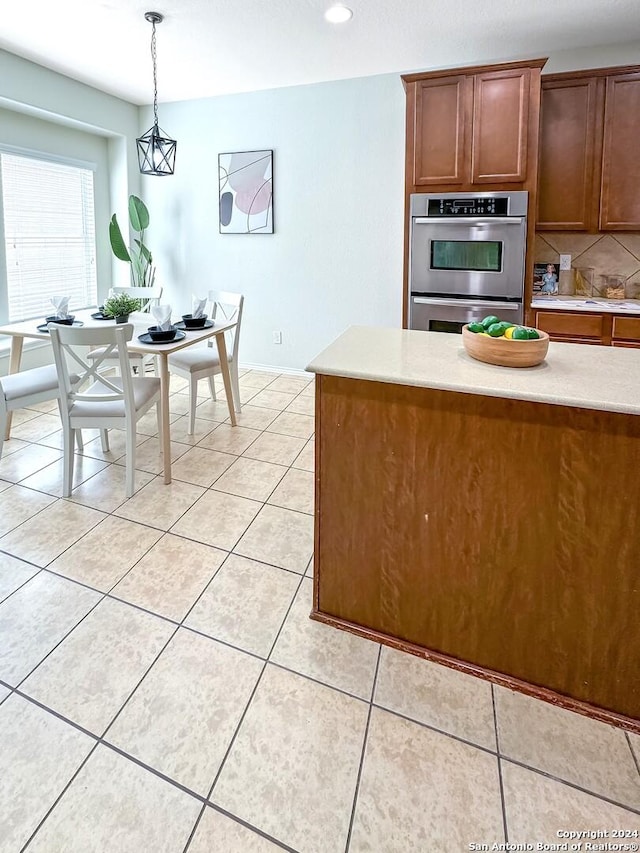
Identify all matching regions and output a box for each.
[402,59,546,192]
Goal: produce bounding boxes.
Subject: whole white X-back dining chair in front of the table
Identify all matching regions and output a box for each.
[50,323,162,498]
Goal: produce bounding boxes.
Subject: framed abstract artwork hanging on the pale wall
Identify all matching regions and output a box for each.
[218,151,273,234]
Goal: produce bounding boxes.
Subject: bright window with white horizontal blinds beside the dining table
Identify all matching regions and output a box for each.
[0,151,97,323]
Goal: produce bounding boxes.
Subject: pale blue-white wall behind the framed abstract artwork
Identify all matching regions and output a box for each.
[141,75,404,369]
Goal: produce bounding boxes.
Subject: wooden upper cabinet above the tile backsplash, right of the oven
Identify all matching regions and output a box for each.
[536,67,640,231]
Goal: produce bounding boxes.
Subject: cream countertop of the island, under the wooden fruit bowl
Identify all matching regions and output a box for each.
[307,326,640,415]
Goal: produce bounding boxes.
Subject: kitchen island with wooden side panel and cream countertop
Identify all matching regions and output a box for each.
[308,327,640,731]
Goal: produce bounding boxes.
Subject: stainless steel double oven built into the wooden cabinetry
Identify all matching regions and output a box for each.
[408,192,528,333]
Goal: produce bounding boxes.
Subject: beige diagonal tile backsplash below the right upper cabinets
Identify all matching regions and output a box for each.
[534,231,640,299]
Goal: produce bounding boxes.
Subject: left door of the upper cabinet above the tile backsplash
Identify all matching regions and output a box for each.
[537,78,604,231]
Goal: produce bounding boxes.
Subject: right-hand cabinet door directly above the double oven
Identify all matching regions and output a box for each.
[471,68,531,184]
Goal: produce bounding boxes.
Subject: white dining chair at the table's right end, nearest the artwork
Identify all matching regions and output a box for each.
[169,290,244,435]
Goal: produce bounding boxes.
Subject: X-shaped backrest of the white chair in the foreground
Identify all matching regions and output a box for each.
[49,323,133,417]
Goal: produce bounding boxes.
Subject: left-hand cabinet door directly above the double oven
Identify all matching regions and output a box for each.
[413,75,469,186]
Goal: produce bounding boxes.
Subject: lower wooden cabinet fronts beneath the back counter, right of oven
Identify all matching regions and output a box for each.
[535,311,640,347]
